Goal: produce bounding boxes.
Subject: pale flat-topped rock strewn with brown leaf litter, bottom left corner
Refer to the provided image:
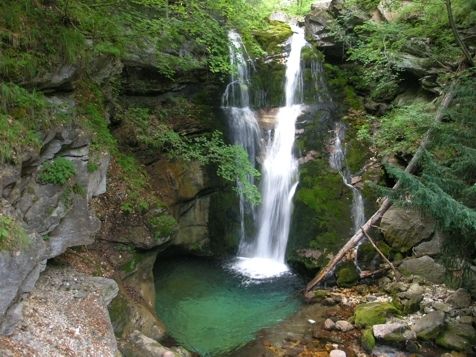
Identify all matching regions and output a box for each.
[0,266,118,357]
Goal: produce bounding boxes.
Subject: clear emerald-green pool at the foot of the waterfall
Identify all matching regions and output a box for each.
[155,258,301,356]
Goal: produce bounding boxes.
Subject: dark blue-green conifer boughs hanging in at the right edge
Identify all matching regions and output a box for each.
[385,71,476,284]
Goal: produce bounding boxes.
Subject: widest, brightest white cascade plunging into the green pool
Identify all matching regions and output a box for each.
[234,27,306,279]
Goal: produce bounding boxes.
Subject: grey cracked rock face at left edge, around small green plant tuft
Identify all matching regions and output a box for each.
[0,127,108,334]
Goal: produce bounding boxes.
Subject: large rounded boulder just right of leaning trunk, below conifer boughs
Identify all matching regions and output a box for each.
[380,206,434,253]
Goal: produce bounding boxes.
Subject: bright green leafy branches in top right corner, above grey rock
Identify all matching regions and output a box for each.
[335,0,476,100]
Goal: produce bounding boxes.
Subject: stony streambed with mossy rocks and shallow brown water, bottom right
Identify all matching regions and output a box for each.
[229,276,476,357]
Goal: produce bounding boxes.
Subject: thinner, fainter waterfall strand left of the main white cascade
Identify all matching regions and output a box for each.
[222,31,261,243]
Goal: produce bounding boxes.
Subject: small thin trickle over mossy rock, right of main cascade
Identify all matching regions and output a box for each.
[329,123,365,233]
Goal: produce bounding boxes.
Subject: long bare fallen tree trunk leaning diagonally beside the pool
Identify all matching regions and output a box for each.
[304,83,455,298]
